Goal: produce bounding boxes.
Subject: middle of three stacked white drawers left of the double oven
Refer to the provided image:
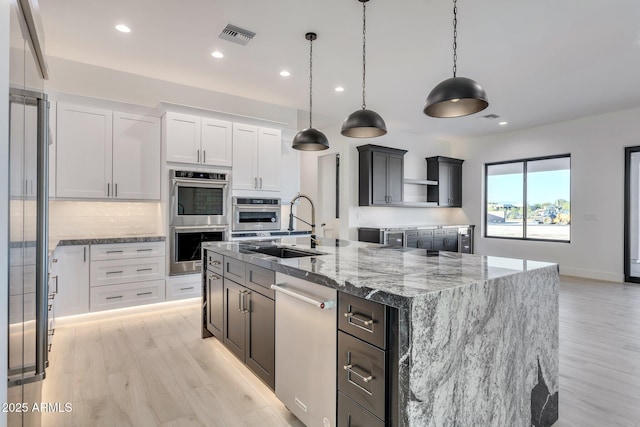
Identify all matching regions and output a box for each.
[89,257,165,287]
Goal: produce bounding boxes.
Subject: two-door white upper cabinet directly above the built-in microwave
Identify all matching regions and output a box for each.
[232,123,282,192]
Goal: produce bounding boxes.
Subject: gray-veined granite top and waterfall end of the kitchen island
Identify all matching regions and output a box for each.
[203,239,559,427]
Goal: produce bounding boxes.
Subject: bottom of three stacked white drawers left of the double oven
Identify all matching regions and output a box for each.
[90,280,164,311]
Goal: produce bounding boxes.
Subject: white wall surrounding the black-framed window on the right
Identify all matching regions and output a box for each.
[452,109,640,281]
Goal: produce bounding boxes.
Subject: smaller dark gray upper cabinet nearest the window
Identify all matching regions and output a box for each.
[427,156,464,208]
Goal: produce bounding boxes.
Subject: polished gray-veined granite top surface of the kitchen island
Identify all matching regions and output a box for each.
[203,238,557,307]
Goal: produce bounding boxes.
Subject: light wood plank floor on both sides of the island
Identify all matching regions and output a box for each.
[42,277,640,427]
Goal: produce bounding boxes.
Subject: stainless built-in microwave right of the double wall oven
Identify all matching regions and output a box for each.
[231,197,280,231]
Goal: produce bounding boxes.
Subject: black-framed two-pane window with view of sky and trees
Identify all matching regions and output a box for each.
[485,154,571,242]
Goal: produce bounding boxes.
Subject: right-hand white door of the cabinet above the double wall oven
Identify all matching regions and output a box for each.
[200,118,233,167]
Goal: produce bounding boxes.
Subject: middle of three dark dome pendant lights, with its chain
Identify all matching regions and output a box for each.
[340,0,387,138]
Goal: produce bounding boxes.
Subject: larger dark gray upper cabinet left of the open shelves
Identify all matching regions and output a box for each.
[357,144,407,206]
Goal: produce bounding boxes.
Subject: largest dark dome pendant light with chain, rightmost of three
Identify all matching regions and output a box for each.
[424,0,489,117]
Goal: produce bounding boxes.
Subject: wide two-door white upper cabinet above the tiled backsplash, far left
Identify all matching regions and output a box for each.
[56,103,160,200]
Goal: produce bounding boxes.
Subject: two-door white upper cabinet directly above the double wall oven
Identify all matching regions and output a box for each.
[164,112,232,166]
